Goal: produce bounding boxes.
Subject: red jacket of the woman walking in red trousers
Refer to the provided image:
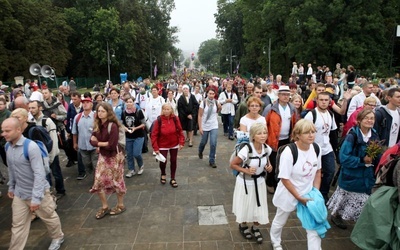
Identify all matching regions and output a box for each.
[151,115,185,151]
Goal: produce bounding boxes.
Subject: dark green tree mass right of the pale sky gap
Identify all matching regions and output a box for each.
[215,0,400,76]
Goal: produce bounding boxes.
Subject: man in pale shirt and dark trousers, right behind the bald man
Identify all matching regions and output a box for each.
[28,101,65,200]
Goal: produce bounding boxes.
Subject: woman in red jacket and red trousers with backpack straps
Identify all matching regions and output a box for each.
[151,103,185,188]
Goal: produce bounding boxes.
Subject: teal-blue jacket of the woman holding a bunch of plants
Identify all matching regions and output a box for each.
[339,126,380,194]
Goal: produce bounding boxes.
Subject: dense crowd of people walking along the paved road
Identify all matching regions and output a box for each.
[0,63,400,250]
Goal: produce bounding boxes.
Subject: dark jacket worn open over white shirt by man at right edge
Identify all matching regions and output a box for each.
[374,106,400,146]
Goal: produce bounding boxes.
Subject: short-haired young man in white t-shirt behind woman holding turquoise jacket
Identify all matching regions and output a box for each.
[304,92,337,203]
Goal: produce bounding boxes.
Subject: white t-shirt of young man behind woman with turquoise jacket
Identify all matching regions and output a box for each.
[304,109,337,155]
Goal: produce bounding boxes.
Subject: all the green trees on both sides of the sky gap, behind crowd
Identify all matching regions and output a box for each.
[0,0,400,84]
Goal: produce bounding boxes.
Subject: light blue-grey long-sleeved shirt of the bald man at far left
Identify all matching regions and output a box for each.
[6,136,50,204]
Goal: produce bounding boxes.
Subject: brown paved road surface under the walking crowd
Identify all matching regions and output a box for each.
[0,120,358,250]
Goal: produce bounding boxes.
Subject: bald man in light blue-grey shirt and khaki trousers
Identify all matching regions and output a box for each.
[1,117,64,250]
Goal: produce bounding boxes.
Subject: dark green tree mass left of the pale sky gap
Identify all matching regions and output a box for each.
[0,0,181,80]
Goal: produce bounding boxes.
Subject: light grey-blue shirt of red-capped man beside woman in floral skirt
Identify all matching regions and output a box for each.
[72,111,96,150]
